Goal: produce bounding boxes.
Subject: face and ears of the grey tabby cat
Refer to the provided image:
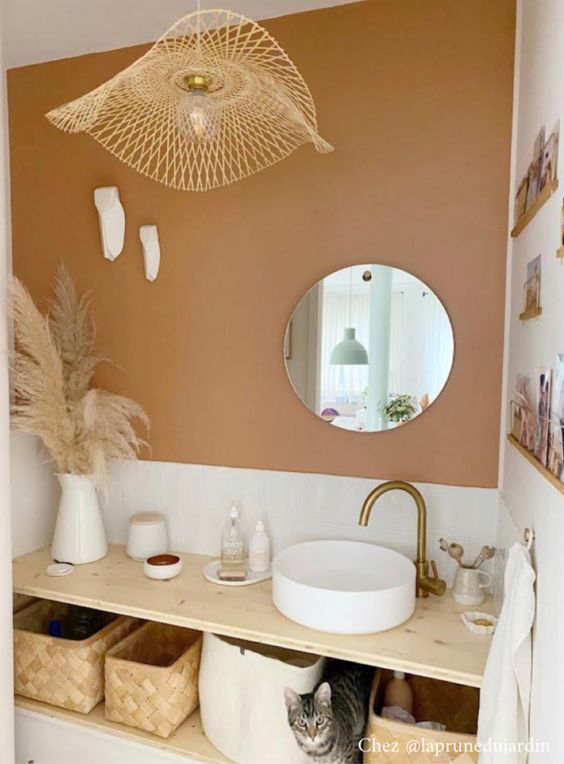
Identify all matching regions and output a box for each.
[284,682,333,753]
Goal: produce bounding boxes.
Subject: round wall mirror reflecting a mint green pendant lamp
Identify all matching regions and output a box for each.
[284,264,454,432]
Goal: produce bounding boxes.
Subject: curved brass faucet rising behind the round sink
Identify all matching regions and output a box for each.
[358,480,446,597]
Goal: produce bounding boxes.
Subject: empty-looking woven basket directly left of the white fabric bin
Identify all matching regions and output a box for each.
[106,623,202,737]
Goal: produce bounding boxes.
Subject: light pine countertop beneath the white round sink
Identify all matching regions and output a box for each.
[13,546,494,687]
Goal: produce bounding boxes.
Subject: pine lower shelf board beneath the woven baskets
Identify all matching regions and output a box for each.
[15,696,231,764]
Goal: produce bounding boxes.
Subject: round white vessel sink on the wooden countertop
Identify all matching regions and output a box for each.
[272,541,415,634]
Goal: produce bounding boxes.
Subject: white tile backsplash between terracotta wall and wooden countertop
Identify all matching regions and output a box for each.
[102,461,498,585]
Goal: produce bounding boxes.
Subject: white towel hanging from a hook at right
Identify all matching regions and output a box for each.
[478,544,535,764]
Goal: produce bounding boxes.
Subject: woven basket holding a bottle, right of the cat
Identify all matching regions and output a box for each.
[363,670,478,764]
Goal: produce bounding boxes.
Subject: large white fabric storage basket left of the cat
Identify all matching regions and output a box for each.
[199,633,325,764]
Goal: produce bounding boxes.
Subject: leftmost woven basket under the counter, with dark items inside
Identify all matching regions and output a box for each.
[14,600,140,714]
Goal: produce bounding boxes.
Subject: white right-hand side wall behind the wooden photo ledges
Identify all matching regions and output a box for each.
[501,0,564,764]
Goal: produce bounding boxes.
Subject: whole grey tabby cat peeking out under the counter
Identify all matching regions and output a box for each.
[284,660,374,764]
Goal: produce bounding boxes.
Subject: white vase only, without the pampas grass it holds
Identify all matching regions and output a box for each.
[51,475,108,565]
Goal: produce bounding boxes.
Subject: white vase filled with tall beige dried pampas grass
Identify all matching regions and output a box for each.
[11,267,148,564]
